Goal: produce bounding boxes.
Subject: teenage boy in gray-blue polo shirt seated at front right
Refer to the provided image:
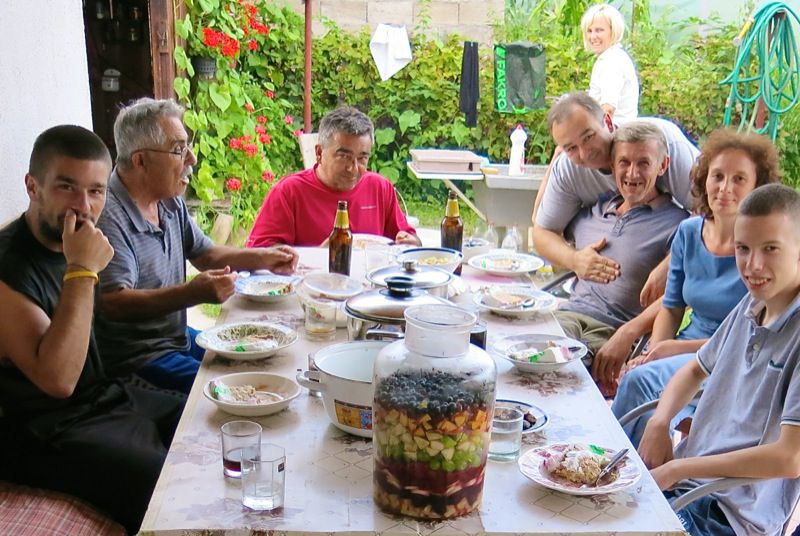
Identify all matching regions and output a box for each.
[639,184,800,536]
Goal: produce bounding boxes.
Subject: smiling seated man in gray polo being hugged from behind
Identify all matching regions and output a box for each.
[556,121,688,394]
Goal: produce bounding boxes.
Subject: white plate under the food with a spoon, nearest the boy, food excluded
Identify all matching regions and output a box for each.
[517,443,642,495]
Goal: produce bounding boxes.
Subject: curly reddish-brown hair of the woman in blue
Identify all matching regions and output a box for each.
[690,128,781,219]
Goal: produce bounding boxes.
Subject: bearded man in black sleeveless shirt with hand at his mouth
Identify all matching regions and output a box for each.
[0,125,185,533]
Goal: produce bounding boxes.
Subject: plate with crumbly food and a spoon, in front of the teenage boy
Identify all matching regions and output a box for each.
[517,443,642,495]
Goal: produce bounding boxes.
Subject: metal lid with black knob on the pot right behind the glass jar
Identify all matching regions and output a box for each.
[344,277,452,324]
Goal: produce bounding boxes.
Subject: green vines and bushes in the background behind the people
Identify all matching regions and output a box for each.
[176,0,800,237]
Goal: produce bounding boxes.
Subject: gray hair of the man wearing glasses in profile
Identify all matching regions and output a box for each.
[114,97,184,168]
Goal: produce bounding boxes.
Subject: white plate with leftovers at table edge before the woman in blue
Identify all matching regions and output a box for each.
[491,333,589,372]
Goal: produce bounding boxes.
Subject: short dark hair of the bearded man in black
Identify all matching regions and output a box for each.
[28,125,111,183]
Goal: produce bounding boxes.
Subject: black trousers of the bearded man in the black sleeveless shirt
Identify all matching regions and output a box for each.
[0,385,185,534]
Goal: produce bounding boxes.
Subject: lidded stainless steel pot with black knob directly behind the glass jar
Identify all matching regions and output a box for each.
[344,277,450,341]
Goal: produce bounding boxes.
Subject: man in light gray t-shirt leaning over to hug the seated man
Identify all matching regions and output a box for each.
[533,92,699,305]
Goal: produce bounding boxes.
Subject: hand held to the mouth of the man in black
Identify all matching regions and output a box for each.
[61,210,114,273]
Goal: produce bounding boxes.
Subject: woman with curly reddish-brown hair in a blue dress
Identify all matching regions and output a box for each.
[612,129,780,445]
